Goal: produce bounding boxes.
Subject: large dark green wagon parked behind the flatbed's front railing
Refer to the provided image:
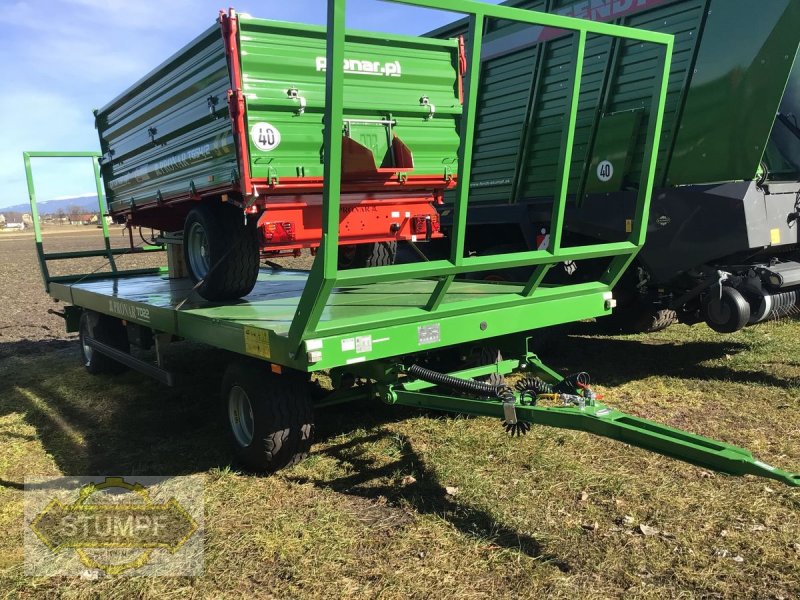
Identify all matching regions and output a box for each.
[426,0,800,332]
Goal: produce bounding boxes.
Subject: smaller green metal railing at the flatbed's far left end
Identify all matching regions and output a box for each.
[22,152,163,292]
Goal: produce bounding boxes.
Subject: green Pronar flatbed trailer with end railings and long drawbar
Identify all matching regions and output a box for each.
[24,0,800,486]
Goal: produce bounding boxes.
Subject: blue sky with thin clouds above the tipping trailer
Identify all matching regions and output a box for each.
[0,0,488,207]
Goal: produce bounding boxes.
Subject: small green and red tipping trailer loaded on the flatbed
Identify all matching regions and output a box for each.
[95,9,465,300]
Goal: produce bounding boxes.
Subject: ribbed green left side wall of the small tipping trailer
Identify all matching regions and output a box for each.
[97,25,237,210]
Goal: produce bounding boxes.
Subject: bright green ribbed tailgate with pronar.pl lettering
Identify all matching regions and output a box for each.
[240,18,461,183]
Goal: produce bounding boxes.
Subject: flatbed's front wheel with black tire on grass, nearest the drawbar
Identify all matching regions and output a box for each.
[222,361,314,472]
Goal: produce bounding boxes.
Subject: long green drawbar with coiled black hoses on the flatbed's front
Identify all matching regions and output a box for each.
[391,365,800,487]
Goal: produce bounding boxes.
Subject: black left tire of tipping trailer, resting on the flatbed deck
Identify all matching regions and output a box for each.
[183,203,259,301]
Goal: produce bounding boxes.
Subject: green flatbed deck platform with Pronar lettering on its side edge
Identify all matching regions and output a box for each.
[50,268,612,371]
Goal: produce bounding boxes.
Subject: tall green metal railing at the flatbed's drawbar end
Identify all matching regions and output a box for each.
[289,0,673,347]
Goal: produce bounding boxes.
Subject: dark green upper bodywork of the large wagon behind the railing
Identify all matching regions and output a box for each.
[429,0,800,203]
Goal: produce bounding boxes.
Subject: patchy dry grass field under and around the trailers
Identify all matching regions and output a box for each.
[0,227,800,599]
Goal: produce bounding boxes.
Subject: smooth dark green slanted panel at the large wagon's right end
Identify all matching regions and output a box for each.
[668,0,800,185]
